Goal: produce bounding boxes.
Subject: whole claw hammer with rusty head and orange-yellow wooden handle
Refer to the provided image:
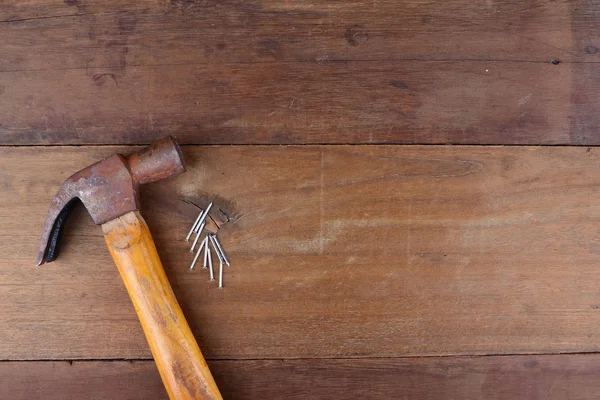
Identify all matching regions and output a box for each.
[37,137,222,400]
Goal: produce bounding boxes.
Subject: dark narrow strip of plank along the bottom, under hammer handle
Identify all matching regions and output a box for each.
[5,354,600,400]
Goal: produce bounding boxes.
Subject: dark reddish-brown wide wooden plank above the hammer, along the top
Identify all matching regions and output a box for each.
[0,0,600,145]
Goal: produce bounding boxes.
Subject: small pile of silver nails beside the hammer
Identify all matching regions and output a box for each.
[185,203,231,289]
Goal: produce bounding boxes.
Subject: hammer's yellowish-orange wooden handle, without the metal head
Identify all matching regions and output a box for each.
[102,211,222,400]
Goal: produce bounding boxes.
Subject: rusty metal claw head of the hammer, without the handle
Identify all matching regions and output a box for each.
[37,136,185,265]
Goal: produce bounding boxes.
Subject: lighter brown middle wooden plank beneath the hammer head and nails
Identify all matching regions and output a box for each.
[0,146,600,360]
